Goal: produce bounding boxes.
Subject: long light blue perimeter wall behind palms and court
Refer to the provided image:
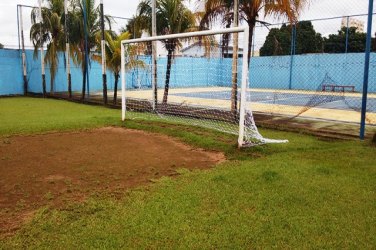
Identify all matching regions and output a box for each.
[0,50,376,95]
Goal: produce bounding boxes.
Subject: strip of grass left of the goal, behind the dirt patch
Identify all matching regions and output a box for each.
[0,97,120,136]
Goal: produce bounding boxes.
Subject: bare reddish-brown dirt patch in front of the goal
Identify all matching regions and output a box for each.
[0,127,225,236]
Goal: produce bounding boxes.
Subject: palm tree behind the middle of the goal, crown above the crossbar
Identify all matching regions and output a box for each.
[136,0,196,104]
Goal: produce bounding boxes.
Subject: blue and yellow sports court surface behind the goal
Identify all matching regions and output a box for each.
[114,87,376,124]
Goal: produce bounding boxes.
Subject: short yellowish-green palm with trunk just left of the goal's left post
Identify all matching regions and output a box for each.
[93,31,144,105]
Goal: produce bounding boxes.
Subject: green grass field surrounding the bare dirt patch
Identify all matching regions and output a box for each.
[0,98,376,249]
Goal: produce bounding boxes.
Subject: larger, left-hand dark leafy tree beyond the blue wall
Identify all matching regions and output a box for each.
[260,21,323,56]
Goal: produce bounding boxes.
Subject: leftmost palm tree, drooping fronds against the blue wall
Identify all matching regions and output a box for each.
[30,0,65,93]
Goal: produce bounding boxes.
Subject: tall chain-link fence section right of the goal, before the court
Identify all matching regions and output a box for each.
[250,1,376,137]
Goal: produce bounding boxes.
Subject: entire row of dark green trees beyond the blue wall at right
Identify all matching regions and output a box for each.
[260,21,376,56]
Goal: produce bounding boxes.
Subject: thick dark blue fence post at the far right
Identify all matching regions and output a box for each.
[360,0,373,140]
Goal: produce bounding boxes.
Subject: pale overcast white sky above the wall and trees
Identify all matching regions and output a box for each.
[0,0,376,48]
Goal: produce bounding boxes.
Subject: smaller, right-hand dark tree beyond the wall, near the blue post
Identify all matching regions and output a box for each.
[324,27,376,53]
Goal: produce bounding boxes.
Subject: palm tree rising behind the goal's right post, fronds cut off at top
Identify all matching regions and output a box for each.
[199,0,309,112]
